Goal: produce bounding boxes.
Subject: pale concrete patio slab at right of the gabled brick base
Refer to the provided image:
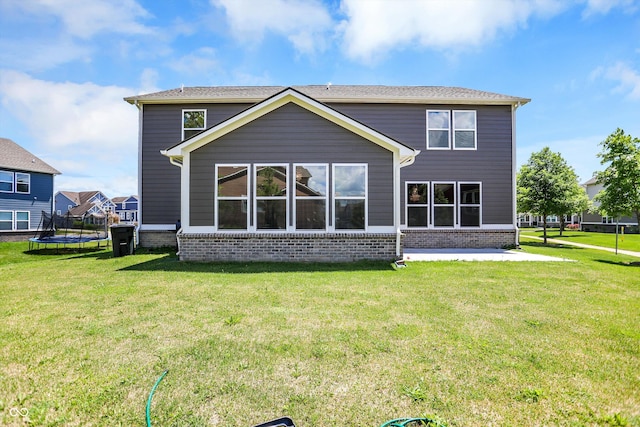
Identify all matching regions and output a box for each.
[403,248,573,262]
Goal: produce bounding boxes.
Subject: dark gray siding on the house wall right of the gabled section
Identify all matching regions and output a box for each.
[332,104,514,224]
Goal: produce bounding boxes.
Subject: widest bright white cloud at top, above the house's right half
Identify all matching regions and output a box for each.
[342,0,566,61]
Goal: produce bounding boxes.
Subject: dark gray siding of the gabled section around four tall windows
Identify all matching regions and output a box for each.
[190,104,393,226]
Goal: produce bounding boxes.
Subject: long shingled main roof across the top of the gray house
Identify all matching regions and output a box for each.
[124,84,531,105]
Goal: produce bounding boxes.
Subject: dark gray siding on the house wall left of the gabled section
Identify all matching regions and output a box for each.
[139,104,249,224]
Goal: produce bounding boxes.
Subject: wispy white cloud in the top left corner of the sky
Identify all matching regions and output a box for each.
[3,0,151,39]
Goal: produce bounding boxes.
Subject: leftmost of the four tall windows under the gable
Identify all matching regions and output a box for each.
[215,165,249,230]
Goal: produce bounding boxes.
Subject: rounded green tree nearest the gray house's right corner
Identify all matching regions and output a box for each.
[516,147,584,244]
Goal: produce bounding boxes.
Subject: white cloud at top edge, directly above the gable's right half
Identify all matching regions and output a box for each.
[211,0,333,53]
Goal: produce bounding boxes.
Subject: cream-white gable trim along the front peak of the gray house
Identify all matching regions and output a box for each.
[160,88,420,166]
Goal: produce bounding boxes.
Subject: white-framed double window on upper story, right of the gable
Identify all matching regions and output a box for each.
[427,110,477,150]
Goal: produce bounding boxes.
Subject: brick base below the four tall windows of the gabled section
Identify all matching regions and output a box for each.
[178,233,396,262]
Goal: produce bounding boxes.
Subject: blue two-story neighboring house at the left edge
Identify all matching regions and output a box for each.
[0,138,60,241]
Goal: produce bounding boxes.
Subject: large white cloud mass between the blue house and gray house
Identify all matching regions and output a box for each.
[0,70,138,194]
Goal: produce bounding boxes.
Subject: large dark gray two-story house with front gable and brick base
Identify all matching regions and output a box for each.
[125,85,529,261]
